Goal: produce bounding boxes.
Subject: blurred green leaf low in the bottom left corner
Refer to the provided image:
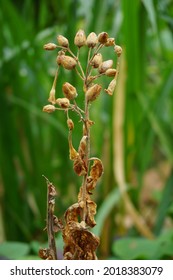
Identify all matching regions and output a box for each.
[0,242,30,260]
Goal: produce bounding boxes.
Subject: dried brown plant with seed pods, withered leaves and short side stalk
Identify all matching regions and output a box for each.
[39,29,122,260]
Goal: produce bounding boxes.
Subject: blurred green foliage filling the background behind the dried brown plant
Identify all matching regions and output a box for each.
[0,0,173,259]
